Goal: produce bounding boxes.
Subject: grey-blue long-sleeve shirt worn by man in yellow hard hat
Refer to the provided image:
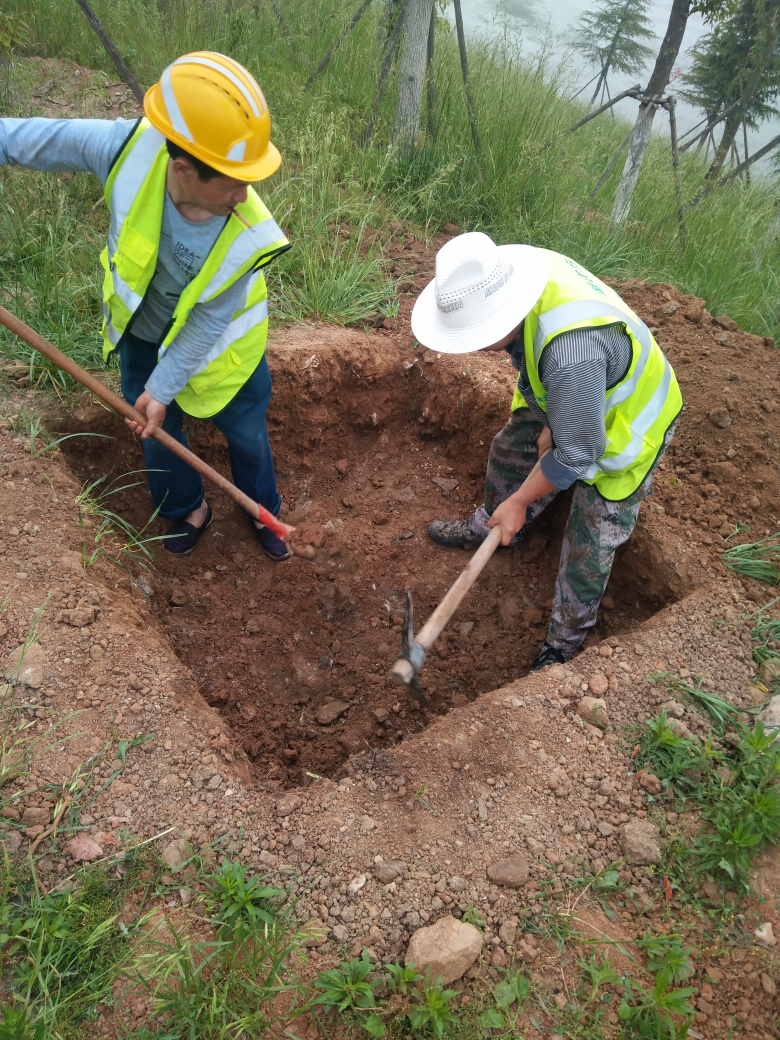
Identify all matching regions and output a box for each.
[0,118,249,405]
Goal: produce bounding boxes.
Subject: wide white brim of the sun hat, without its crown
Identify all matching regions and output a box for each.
[412,245,550,354]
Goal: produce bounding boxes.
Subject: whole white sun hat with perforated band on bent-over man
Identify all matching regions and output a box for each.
[412,231,549,354]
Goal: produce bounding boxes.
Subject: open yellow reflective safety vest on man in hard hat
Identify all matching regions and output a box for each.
[100,119,290,418]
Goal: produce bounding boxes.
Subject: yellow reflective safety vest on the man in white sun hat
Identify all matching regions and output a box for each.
[512,250,682,501]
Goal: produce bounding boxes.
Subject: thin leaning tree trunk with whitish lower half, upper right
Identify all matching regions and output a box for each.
[612,0,735,224]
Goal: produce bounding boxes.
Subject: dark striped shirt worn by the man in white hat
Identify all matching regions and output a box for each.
[506,324,632,490]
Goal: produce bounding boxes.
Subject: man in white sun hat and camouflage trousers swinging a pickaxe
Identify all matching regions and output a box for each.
[412,232,682,671]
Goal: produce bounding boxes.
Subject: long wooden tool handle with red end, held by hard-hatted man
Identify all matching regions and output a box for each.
[0,307,294,540]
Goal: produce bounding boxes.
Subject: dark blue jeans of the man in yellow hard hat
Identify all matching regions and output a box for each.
[120,335,282,521]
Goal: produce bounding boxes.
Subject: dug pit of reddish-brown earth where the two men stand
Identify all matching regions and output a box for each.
[57,327,685,786]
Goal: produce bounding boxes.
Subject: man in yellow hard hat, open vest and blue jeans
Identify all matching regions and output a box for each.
[0,51,291,560]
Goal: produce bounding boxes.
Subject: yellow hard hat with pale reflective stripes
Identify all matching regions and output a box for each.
[144,51,282,181]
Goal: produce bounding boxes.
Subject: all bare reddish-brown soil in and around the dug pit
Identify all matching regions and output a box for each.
[0,233,780,1036]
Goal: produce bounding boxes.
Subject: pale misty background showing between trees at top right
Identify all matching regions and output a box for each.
[455,0,780,172]
